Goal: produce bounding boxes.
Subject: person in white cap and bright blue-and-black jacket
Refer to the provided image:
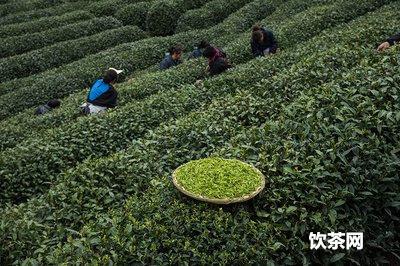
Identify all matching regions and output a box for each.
[81,68,123,114]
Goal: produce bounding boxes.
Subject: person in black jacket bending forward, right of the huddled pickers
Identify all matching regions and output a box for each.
[250,26,278,57]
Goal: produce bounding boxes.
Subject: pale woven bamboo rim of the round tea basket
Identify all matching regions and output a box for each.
[172,159,265,204]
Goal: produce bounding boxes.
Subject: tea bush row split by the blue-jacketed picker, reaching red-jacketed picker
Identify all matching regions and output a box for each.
[0,61,204,151]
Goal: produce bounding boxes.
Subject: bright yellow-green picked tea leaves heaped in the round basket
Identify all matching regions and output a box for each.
[175,158,264,199]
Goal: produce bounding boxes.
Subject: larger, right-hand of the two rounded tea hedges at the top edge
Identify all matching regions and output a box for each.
[146,0,210,35]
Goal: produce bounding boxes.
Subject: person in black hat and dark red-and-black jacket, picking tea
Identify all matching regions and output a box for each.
[203,46,230,76]
